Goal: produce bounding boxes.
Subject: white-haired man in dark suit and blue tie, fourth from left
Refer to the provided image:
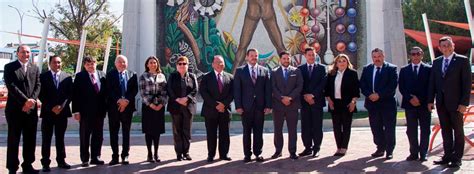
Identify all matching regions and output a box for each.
[106,55,138,165]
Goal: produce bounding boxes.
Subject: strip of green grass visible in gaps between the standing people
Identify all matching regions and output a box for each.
[132,111,405,123]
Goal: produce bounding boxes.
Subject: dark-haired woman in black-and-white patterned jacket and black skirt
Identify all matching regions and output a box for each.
[139,56,168,162]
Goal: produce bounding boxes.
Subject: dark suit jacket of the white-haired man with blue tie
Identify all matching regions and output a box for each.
[106,69,138,114]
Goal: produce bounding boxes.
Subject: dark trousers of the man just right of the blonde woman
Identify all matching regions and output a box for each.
[368,109,397,154]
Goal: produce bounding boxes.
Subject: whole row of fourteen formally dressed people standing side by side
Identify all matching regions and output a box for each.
[4,37,471,173]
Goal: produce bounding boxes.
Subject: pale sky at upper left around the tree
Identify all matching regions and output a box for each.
[0,0,124,47]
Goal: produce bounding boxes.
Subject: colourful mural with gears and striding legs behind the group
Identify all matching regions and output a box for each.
[162,0,358,76]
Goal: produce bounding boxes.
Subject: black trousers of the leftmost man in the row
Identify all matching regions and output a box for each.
[5,112,38,171]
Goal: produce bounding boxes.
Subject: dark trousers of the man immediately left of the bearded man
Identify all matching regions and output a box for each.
[242,106,265,157]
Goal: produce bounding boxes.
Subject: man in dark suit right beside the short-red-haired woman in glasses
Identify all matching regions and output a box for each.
[199,55,234,162]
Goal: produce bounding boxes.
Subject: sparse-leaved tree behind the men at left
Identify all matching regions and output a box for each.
[32,0,121,73]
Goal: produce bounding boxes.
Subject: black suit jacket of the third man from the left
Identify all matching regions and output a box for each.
[72,70,107,120]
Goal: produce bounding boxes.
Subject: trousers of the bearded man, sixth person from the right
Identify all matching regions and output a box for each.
[273,110,298,154]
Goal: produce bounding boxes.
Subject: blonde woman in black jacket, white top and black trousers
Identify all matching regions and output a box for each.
[325,54,360,156]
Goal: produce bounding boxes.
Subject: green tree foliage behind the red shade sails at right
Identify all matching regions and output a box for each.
[402,0,474,62]
